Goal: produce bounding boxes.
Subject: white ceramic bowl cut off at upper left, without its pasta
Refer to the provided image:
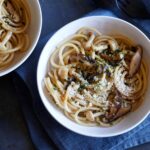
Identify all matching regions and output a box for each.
[0,0,42,77]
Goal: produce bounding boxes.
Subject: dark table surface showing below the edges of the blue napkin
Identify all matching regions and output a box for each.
[0,74,150,150]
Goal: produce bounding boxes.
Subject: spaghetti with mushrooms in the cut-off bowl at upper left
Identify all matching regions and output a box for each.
[0,0,30,69]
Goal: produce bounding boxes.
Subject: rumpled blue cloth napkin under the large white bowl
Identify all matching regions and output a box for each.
[13,0,150,150]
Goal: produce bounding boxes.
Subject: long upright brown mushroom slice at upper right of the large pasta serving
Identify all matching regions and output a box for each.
[129,46,143,77]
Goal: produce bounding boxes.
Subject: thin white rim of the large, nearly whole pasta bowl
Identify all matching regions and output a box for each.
[36,15,150,138]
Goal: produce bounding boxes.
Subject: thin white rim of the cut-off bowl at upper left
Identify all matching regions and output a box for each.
[0,0,43,77]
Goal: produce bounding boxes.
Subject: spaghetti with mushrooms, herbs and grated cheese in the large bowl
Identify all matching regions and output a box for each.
[44,27,148,127]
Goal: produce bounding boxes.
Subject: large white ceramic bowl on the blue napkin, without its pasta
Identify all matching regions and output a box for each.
[37,16,150,137]
